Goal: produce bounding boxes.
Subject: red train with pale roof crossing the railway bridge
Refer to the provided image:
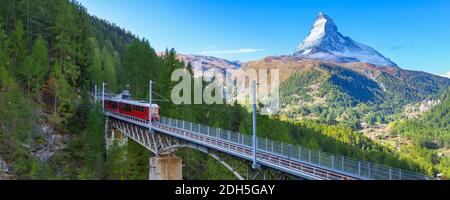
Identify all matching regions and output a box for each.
[104,92,160,121]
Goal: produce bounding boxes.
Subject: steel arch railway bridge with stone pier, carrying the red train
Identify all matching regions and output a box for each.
[95,83,431,180]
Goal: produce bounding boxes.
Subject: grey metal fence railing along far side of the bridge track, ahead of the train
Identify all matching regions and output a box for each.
[160,117,430,180]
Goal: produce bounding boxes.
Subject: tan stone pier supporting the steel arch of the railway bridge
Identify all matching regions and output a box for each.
[149,154,183,180]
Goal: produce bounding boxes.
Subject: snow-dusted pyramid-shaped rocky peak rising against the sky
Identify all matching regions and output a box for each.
[294,13,397,67]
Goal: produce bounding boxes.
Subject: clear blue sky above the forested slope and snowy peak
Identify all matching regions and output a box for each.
[79,0,450,74]
